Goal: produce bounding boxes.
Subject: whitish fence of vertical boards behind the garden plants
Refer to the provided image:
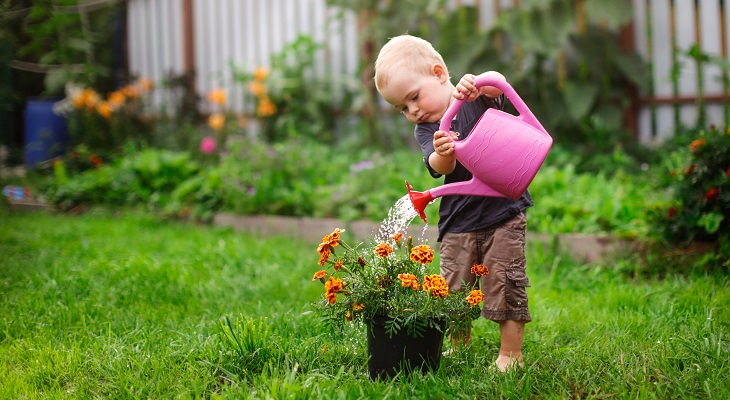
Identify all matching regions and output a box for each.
[127,0,730,144]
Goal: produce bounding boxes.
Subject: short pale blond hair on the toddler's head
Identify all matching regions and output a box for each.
[375,35,449,92]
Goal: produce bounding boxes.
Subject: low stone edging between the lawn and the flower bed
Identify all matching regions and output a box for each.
[213,213,636,262]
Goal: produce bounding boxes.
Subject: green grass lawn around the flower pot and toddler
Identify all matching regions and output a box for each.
[0,208,730,399]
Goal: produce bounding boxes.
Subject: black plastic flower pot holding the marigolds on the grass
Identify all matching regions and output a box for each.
[367,315,446,380]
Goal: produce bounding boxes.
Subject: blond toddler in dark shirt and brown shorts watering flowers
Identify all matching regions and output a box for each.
[375,35,533,372]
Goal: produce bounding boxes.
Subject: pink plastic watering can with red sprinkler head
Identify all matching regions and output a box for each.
[406,75,553,222]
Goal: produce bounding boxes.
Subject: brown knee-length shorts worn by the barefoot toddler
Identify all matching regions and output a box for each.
[439,212,532,321]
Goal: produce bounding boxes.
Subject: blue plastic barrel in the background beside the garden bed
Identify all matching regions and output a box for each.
[23,99,69,168]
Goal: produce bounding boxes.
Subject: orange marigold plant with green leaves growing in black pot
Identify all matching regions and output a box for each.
[312,228,484,336]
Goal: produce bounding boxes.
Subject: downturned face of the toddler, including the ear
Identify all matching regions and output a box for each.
[380,64,453,124]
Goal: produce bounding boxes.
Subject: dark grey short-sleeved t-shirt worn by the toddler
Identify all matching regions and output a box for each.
[415,95,533,242]
